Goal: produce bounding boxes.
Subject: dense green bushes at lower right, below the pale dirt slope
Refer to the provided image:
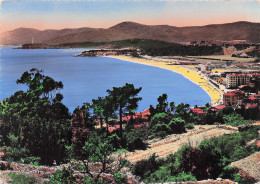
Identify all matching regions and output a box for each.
[132,127,260,183]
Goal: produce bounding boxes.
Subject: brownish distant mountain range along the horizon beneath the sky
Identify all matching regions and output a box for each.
[0,21,260,45]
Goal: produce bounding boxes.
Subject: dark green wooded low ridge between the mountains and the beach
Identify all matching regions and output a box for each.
[56,39,222,57]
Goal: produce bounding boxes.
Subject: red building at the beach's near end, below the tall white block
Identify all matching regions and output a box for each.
[223,90,245,105]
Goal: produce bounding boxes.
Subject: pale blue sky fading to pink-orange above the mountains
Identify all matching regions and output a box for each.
[0,0,260,32]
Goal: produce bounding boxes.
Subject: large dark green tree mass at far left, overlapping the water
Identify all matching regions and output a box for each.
[0,68,71,164]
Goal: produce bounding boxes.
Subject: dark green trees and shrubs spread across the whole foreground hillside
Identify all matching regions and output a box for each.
[0,69,260,183]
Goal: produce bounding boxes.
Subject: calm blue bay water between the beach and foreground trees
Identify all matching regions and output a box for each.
[0,47,210,112]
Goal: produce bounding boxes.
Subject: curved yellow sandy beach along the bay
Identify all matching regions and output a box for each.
[106,56,223,105]
